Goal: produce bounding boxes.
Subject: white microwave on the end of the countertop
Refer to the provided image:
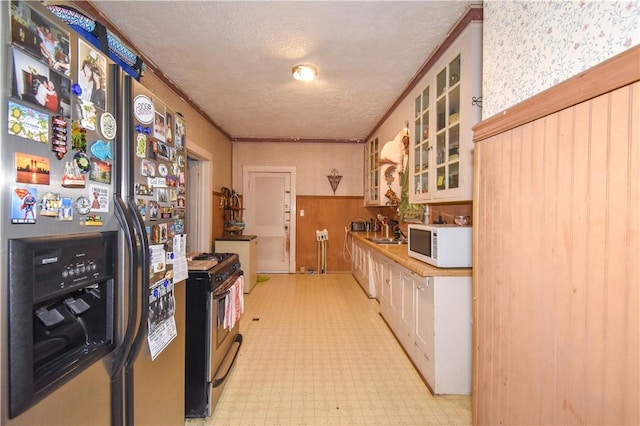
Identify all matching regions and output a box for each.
[407,225,473,268]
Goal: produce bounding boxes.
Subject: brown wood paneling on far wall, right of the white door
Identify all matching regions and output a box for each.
[296,196,377,272]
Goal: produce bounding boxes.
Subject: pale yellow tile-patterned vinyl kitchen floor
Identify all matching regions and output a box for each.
[186,274,471,426]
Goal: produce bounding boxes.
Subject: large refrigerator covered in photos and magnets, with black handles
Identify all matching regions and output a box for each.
[0,0,187,425]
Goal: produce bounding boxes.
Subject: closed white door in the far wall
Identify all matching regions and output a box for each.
[243,166,295,273]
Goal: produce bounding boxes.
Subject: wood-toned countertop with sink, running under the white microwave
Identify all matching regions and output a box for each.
[349,231,473,277]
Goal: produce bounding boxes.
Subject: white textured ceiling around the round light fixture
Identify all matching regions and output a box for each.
[91,0,470,140]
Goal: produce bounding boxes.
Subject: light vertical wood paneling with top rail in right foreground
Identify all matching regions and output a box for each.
[473,48,640,425]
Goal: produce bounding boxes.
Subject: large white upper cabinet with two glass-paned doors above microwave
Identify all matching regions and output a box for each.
[409,21,482,203]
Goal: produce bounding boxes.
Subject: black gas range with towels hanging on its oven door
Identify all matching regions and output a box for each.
[185,253,243,418]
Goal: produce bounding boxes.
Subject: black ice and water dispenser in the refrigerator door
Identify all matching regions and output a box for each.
[8,232,117,417]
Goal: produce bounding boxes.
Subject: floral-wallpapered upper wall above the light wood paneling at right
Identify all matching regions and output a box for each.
[482,0,640,119]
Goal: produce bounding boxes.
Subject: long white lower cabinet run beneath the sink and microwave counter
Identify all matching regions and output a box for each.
[351,239,472,395]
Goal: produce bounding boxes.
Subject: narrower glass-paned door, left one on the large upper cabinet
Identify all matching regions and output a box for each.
[412,86,431,195]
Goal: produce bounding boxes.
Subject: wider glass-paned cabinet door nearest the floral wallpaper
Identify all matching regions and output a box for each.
[434,55,460,191]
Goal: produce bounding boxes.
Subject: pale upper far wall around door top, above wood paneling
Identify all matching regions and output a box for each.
[233,142,365,197]
